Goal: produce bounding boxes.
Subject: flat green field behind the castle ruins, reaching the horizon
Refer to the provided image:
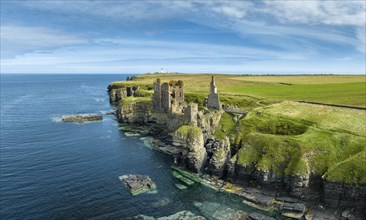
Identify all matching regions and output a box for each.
[113,74,366,107]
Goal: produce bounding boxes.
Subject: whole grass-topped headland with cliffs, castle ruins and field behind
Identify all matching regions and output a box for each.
[108,74,366,216]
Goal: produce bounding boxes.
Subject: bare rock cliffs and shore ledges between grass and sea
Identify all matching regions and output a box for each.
[109,78,366,219]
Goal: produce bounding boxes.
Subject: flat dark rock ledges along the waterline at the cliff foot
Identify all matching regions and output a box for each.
[126,124,363,220]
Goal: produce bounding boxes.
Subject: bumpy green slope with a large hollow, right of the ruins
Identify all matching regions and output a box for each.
[236,101,366,184]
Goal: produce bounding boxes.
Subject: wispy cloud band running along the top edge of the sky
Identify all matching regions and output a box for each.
[14,0,366,26]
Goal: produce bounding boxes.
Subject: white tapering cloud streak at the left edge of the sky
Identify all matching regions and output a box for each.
[0,25,87,59]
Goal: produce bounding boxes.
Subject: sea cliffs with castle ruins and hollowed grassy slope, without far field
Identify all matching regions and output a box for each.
[108,75,366,218]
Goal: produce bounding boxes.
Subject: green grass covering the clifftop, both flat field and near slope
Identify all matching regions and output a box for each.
[111,74,366,184]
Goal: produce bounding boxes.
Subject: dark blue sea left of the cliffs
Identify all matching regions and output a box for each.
[0,74,280,219]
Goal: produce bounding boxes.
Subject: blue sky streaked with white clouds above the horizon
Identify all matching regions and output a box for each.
[1,0,366,74]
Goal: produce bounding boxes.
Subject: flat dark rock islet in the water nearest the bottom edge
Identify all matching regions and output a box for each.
[119,174,156,195]
